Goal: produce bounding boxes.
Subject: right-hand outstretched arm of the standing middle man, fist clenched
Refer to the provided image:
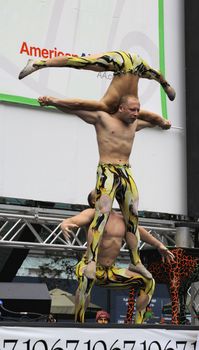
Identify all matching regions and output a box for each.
[138,110,171,130]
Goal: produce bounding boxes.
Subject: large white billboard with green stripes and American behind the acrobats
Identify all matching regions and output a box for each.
[0,0,187,214]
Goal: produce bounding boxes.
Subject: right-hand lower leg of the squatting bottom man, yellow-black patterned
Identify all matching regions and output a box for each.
[135,278,155,324]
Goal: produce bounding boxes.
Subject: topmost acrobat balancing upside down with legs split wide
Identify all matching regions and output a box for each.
[19,50,175,113]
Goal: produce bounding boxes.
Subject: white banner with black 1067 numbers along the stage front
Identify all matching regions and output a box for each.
[0,327,199,350]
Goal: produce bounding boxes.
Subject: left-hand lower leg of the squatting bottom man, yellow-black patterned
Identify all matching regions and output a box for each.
[75,261,95,323]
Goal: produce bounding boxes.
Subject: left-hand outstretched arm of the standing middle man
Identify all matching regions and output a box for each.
[38,96,99,124]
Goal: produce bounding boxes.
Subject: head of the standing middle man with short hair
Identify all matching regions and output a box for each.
[118,95,140,124]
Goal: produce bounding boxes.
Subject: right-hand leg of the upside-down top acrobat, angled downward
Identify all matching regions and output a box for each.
[137,55,176,101]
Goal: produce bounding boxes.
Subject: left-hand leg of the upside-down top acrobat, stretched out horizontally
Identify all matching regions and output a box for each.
[19,52,122,79]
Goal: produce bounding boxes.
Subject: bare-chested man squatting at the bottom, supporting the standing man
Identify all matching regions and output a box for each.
[61,190,173,324]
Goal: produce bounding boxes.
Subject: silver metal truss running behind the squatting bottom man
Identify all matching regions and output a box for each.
[0,204,179,256]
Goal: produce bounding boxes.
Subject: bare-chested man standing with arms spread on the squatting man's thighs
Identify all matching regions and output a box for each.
[38,95,171,279]
